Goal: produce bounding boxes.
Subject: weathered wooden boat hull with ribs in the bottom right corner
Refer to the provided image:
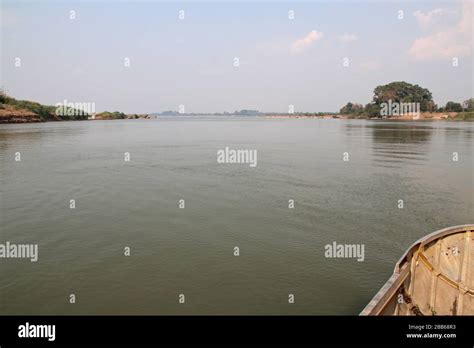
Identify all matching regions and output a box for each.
[360,225,474,315]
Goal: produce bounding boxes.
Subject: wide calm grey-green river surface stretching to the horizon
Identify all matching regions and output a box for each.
[0,117,474,314]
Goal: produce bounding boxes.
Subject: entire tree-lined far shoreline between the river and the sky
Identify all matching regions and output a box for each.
[0,81,474,123]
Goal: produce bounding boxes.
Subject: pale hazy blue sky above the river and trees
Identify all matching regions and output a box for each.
[0,0,473,113]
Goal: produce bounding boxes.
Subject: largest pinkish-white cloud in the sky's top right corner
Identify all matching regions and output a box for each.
[408,0,474,61]
